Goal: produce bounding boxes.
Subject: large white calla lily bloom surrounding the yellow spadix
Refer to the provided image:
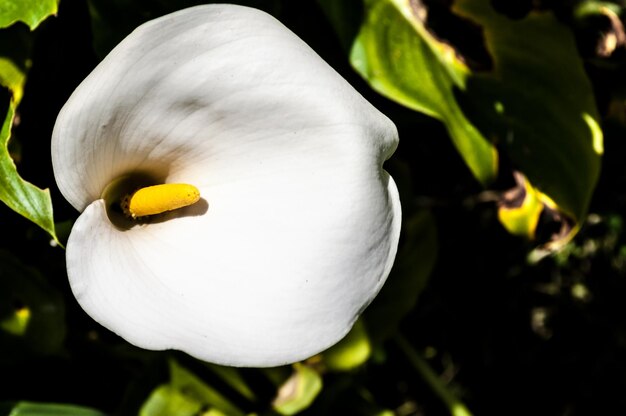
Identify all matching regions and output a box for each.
[52,4,401,367]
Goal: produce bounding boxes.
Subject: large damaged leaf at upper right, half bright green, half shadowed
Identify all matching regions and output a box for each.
[351,0,603,246]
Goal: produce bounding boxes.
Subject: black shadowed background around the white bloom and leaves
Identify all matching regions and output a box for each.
[0,0,626,416]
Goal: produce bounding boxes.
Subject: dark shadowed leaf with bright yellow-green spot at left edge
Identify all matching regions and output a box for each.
[0,251,65,362]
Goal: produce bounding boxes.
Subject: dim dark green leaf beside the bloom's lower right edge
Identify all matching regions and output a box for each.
[364,210,438,344]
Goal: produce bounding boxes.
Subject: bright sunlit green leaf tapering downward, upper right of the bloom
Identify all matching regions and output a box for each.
[350,0,498,184]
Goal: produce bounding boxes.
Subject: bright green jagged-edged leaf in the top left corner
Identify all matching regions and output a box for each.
[0,0,59,30]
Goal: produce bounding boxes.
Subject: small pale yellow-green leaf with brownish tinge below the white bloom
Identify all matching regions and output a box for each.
[272,363,322,415]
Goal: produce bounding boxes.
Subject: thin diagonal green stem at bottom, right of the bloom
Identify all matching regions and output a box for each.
[394,334,472,416]
